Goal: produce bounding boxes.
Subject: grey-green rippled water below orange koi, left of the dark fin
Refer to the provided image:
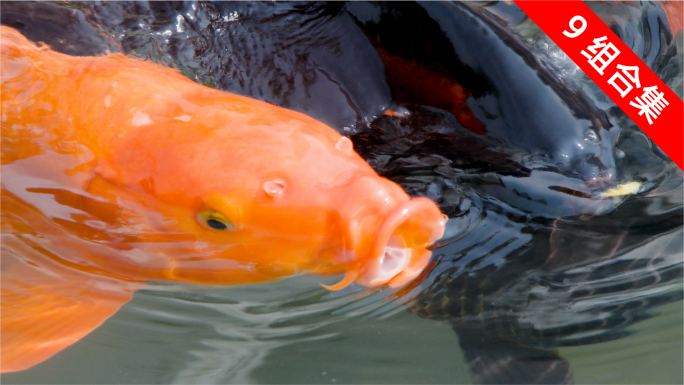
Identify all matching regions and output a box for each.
[3,277,467,383]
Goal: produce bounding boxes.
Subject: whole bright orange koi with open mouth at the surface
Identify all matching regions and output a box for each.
[0,27,446,372]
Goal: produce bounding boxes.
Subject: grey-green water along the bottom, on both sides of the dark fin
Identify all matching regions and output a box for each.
[2,277,684,384]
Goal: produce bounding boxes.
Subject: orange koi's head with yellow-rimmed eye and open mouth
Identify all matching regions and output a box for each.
[95,86,446,289]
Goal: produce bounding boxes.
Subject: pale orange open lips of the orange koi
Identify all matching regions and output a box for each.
[357,197,447,287]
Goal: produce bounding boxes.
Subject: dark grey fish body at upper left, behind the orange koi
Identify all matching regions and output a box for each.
[0,1,391,135]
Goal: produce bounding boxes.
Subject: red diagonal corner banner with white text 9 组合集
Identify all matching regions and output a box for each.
[515,0,684,168]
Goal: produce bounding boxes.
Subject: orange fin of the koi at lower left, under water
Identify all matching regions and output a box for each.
[0,242,141,373]
